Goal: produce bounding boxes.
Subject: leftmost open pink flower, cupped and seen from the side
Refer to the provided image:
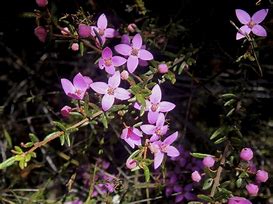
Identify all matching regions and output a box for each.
[61,73,92,100]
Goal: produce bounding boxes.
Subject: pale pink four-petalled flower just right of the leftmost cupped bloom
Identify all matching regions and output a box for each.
[90,71,130,111]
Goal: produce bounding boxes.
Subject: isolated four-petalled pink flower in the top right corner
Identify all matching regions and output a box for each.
[235,9,268,40]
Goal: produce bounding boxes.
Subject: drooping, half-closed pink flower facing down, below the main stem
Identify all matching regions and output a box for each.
[120,127,142,148]
